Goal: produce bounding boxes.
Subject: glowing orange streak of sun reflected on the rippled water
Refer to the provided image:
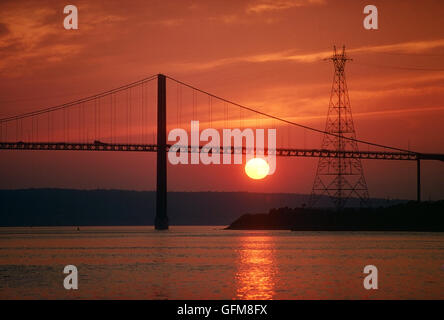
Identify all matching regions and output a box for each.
[236,236,277,300]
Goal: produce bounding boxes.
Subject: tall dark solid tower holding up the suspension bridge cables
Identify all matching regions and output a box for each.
[154,74,168,230]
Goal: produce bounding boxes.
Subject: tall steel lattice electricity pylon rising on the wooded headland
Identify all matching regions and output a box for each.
[309,46,369,211]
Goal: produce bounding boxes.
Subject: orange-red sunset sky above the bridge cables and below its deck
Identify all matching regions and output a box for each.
[0,0,444,199]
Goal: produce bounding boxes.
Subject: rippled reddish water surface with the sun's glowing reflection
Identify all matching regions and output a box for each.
[0,226,444,299]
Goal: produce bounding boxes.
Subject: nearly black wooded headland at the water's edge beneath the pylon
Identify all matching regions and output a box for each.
[227,200,444,232]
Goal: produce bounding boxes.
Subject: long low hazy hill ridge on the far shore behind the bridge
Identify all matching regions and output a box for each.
[0,189,401,226]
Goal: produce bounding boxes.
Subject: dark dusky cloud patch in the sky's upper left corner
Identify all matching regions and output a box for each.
[0,3,126,77]
